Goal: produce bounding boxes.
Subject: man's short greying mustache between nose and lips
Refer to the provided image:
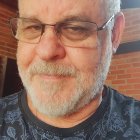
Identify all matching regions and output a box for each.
[28,60,78,77]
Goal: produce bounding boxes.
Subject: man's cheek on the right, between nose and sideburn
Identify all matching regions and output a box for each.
[68,48,99,72]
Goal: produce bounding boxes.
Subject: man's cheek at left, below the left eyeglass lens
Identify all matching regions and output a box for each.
[17,43,34,69]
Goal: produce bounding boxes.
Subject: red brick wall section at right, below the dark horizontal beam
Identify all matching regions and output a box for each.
[106,51,140,100]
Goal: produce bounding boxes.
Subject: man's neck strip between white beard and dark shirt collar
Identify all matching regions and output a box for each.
[27,88,102,128]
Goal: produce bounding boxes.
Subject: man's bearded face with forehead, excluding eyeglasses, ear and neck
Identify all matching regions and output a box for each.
[17,0,111,117]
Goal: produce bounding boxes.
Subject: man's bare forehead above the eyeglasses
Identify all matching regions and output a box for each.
[19,0,104,22]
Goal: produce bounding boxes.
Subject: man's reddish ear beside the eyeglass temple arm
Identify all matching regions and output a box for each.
[112,12,125,53]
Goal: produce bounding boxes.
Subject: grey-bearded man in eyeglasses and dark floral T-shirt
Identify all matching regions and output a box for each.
[0,0,140,140]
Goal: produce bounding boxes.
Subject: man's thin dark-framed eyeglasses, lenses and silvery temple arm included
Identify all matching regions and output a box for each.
[10,15,114,47]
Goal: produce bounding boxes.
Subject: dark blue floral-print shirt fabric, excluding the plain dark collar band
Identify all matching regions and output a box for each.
[0,88,140,140]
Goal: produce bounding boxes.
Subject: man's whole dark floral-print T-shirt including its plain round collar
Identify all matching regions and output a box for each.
[0,87,140,140]
